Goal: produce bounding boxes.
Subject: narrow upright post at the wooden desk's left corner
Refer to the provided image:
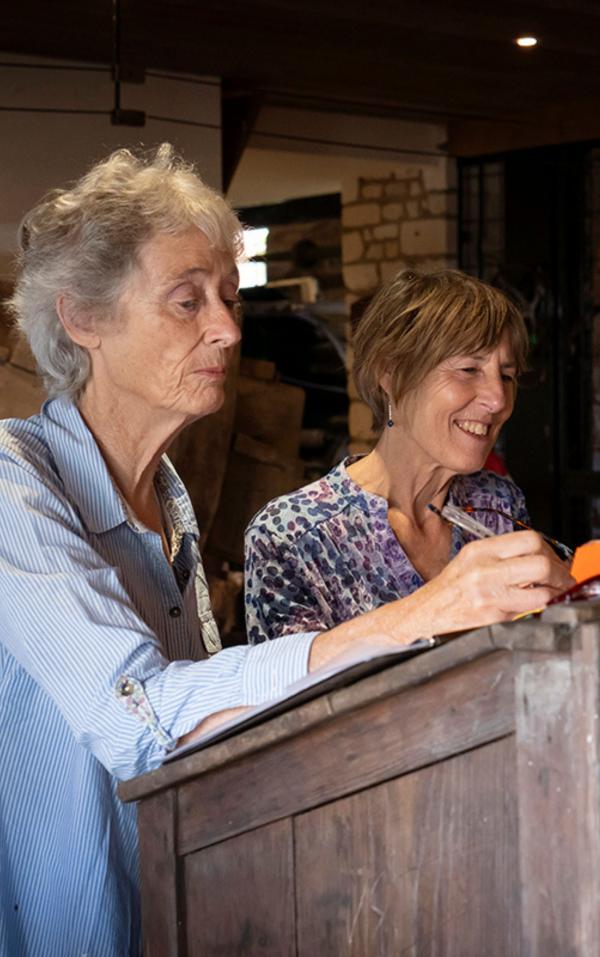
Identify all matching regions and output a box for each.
[138,791,184,957]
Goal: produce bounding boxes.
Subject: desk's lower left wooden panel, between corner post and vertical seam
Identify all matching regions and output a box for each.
[184,821,296,957]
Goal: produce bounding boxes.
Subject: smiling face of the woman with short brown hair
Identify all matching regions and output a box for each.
[393,334,516,474]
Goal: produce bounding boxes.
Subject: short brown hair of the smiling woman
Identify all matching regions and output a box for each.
[352,269,528,430]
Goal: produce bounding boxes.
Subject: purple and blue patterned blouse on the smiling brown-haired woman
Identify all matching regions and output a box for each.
[245,457,528,644]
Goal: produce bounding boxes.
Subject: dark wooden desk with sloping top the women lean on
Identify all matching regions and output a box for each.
[121,604,600,957]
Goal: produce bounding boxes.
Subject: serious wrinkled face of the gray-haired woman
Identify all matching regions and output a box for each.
[93,228,240,421]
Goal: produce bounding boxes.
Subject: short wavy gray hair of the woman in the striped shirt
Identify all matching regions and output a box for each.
[7,143,242,398]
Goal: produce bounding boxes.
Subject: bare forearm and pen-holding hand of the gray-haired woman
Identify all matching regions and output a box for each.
[309,531,574,671]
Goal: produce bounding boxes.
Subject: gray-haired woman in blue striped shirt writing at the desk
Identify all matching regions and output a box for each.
[0,146,566,957]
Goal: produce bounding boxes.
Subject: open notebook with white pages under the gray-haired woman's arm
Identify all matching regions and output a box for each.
[164,638,438,764]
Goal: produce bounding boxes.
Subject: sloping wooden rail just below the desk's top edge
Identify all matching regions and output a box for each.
[178,652,514,854]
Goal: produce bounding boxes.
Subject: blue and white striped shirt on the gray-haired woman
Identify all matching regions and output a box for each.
[0,399,313,957]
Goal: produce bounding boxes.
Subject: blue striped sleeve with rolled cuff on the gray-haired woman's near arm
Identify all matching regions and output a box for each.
[0,455,314,779]
